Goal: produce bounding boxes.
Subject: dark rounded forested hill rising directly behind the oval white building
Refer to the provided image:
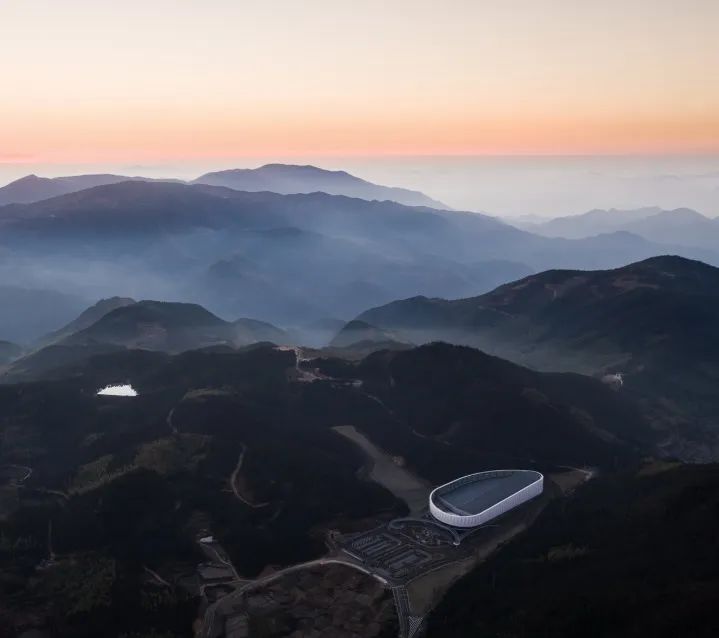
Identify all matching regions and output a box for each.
[358,343,655,482]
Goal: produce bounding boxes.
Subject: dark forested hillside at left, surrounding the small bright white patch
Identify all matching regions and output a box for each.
[0,344,406,638]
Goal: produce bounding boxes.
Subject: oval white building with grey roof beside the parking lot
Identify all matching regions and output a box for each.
[429,470,544,527]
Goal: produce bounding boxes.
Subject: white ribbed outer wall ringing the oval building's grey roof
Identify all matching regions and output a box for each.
[429,470,544,527]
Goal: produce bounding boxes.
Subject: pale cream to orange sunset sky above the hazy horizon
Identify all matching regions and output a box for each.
[0,0,719,164]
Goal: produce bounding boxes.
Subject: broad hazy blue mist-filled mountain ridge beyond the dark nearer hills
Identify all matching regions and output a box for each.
[0,175,719,341]
